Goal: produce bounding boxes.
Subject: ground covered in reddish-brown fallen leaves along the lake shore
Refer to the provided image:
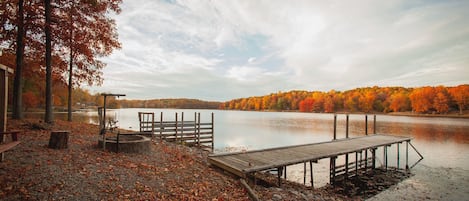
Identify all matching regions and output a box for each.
[0,120,346,200]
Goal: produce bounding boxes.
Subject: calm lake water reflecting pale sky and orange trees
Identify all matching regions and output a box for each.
[31,109,469,186]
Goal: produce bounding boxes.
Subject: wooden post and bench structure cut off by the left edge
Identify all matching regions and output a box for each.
[0,64,20,161]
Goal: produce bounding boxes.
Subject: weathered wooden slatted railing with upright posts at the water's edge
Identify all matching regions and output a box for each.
[135,112,214,151]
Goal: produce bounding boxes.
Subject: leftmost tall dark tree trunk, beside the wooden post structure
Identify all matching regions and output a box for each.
[13,0,24,119]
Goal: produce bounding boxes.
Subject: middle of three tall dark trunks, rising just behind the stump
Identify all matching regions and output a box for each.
[44,0,54,123]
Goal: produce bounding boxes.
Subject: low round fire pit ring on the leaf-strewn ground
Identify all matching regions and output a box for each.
[98,135,151,153]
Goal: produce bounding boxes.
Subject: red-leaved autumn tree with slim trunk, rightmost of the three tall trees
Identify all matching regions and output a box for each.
[55,0,122,121]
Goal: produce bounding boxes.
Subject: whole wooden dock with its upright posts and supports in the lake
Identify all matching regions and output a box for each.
[208,115,423,189]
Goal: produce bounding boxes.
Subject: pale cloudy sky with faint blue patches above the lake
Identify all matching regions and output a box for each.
[91,0,469,101]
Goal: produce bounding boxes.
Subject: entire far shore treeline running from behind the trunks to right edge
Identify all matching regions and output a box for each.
[15,84,469,114]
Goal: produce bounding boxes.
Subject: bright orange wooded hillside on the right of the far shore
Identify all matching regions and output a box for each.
[220,84,469,114]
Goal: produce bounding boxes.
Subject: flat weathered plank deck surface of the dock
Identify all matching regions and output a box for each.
[208,134,412,183]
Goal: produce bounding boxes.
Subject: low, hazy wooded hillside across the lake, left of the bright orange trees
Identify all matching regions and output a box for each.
[118,98,221,109]
